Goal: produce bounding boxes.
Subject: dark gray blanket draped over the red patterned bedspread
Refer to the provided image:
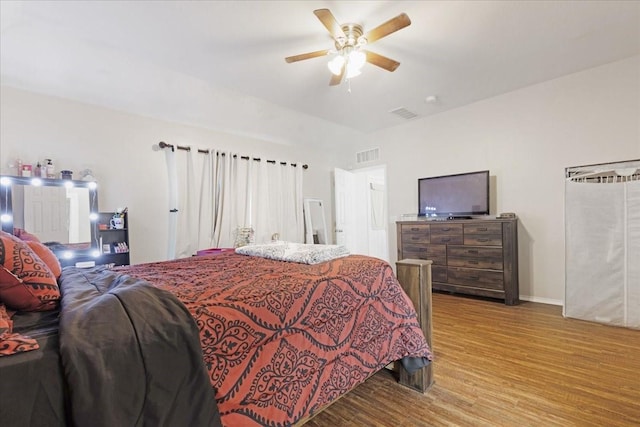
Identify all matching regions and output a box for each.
[60,268,221,427]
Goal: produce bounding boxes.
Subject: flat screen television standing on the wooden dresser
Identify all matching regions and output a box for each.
[418,170,489,217]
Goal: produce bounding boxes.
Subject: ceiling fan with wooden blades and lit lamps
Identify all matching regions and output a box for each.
[285,9,411,86]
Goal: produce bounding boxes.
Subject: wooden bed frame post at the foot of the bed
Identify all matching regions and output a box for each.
[396,259,434,393]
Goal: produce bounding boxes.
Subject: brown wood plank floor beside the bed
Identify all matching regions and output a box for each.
[305,293,640,427]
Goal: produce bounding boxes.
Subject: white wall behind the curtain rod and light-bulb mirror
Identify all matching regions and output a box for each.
[0,86,345,263]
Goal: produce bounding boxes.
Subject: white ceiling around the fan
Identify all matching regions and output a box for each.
[0,0,640,145]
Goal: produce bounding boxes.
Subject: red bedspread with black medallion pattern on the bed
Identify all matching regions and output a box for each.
[117,253,431,426]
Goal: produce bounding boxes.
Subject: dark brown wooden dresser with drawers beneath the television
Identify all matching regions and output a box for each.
[396,219,519,305]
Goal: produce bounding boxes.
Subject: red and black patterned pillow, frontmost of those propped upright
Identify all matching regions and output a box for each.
[0,231,60,311]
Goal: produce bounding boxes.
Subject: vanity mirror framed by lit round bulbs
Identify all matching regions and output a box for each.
[0,176,98,253]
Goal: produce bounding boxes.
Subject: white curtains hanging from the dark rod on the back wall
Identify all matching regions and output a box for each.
[166,150,304,259]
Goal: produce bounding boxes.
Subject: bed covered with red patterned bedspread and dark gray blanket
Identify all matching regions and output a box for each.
[0,252,431,426]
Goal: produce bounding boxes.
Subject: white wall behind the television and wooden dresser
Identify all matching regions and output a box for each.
[351,56,640,303]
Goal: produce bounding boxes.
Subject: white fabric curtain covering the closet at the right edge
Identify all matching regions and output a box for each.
[564,162,640,328]
